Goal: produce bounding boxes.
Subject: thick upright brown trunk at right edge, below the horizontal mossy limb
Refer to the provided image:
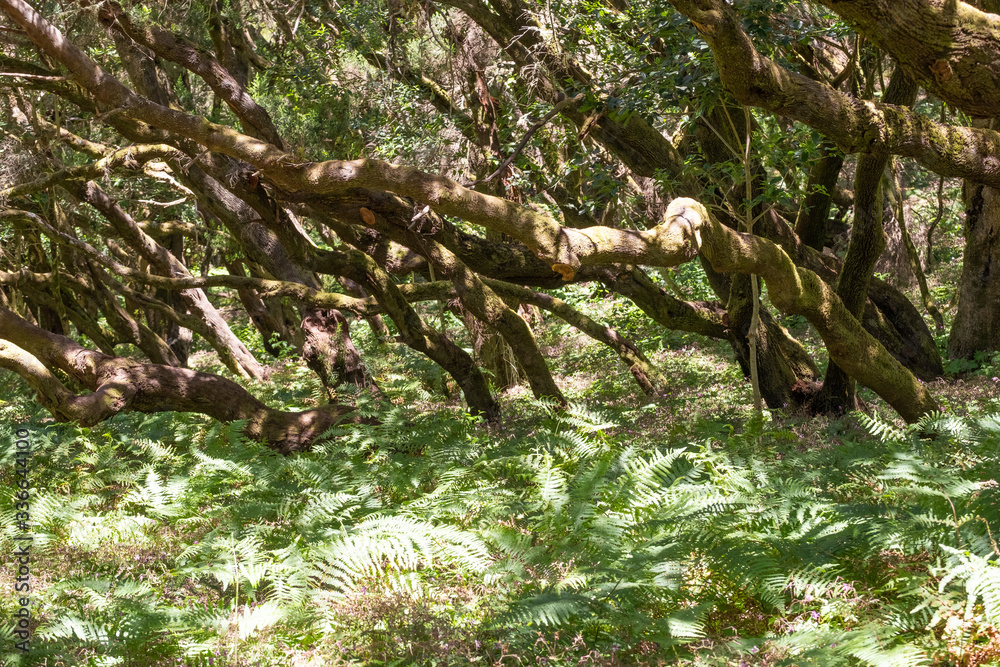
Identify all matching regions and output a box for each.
[948,182,1000,359]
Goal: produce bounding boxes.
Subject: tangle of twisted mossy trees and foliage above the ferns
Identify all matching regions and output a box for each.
[0,0,1000,452]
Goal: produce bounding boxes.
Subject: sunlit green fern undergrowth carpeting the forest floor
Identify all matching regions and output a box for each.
[0,394,1000,666]
